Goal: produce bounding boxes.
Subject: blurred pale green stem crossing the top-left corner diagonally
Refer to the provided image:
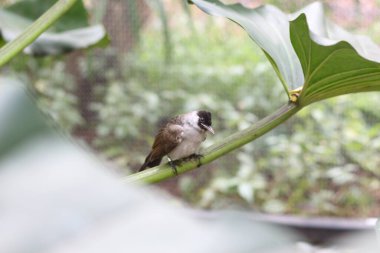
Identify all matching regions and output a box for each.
[0,0,77,67]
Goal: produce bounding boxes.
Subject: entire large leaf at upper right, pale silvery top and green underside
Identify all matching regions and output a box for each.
[192,0,380,105]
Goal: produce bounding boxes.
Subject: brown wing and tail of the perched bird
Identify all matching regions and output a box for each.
[139,122,183,171]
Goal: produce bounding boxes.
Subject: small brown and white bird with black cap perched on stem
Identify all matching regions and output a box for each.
[139,111,214,174]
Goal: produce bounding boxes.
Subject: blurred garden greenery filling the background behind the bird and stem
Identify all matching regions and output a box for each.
[2,0,380,217]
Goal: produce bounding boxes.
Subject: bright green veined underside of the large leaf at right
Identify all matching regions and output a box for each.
[290,14,380,106]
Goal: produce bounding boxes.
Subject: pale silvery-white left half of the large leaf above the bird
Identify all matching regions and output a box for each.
[192,0,303,94]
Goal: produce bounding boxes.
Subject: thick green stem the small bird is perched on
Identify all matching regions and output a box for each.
[125,102,301,184]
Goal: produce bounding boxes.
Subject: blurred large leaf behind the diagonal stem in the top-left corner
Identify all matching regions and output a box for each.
[0,0,107,55]
